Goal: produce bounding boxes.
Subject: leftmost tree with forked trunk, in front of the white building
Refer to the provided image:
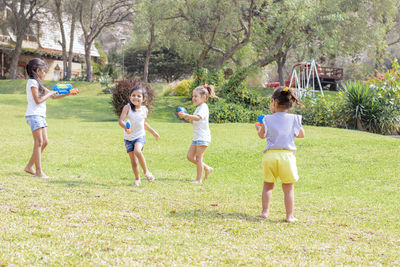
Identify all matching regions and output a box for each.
[2,0,47,79]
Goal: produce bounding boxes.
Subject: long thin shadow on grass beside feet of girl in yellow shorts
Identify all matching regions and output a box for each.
[169,209,270,223]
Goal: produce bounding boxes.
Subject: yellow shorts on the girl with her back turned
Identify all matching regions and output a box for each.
[262,150,299,184]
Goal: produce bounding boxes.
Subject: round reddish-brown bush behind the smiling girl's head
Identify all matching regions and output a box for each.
[111,79,154,117]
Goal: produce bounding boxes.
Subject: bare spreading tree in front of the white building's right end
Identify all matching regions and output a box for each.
[78,0,133,81]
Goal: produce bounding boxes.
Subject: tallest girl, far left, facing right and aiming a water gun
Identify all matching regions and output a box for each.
[24,58,77,179]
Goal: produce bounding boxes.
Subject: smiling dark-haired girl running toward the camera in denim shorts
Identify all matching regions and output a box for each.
[119,83,160,186]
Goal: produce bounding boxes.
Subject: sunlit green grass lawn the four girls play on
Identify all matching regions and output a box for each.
[0,91,400,266]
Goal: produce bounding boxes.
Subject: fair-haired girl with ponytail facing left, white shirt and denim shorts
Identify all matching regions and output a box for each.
[178,84,217,183]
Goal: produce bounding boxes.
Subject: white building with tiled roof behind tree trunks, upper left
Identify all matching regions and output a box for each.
[0,7,100,81]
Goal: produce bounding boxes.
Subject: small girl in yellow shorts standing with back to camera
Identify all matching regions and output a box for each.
[256,87,304,223]
